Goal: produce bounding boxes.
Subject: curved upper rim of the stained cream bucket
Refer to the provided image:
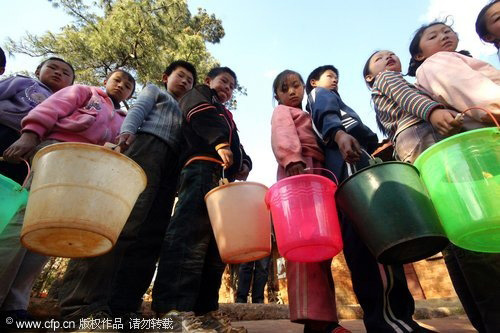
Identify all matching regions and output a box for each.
[31,142,147,186]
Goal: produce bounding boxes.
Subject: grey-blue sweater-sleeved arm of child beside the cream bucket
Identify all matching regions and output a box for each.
[117,84,160,150]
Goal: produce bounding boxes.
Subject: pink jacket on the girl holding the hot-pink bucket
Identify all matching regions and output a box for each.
[271,105,324,168]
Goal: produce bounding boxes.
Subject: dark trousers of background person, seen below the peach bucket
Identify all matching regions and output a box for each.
[236,257,271,303]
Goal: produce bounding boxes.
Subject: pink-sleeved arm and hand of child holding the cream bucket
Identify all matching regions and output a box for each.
[3,85,92,162]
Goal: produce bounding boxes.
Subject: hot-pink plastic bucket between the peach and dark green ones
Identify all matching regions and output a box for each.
[266,174,343,262]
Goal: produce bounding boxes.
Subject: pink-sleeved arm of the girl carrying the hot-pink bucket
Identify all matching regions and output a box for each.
[271,105,306,176]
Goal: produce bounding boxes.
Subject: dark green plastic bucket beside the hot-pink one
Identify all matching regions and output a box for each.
[335,162,448,264]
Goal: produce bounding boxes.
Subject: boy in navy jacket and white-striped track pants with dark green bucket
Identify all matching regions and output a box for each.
[306,65,428,332]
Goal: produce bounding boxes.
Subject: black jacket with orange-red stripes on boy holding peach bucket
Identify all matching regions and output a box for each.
[179,85,252,178]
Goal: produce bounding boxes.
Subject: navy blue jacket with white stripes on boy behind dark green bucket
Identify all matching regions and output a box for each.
[307,88,378,181]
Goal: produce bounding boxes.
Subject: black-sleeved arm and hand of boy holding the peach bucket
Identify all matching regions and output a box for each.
[179,85,234,168]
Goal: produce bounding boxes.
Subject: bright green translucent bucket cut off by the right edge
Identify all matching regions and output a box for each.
[415,127,500,253]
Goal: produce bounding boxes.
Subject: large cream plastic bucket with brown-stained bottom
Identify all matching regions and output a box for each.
[21,143,146,258]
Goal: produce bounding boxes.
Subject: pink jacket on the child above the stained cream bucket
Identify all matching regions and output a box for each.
[21,85,125,145]
